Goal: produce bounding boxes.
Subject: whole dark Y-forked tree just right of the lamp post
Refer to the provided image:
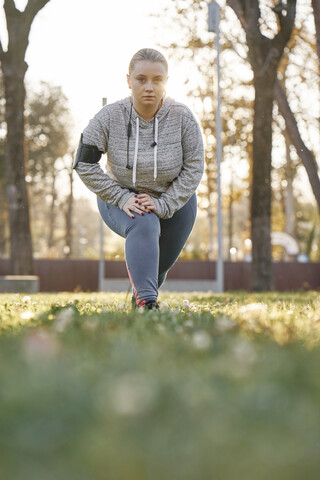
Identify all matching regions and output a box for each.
[227,0,296,291]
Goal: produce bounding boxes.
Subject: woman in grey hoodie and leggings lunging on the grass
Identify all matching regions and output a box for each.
[73,49,204,309]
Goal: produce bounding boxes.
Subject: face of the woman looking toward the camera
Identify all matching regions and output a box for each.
[127,60,168,107]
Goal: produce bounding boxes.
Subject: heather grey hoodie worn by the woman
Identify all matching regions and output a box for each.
[75,97,204,218]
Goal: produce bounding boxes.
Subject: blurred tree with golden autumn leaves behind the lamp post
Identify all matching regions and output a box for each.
[155,0,253,258]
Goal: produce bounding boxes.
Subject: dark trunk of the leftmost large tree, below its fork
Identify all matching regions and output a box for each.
[2,62,34,275]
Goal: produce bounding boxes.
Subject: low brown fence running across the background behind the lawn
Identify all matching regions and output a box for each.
[0,259,320,292]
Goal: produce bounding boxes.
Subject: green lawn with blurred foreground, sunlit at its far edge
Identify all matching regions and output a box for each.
[0,292,320,480]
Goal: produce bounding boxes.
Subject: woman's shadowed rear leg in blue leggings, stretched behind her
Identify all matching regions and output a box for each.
[158,194,197,288]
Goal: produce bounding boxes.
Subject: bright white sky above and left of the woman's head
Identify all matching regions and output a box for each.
[1,0,190,135]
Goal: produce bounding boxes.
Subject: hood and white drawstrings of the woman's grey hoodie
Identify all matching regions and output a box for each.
[120,97,175,186]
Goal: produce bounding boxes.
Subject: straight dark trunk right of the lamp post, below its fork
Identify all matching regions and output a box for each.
[251,76,273,291]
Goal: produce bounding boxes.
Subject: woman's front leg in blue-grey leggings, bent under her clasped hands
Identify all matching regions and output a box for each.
[97,197,160,306]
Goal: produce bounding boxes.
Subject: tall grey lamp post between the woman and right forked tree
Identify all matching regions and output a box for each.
[208,2,224,293]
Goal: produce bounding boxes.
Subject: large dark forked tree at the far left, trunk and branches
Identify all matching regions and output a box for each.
[0,0,50,275]
